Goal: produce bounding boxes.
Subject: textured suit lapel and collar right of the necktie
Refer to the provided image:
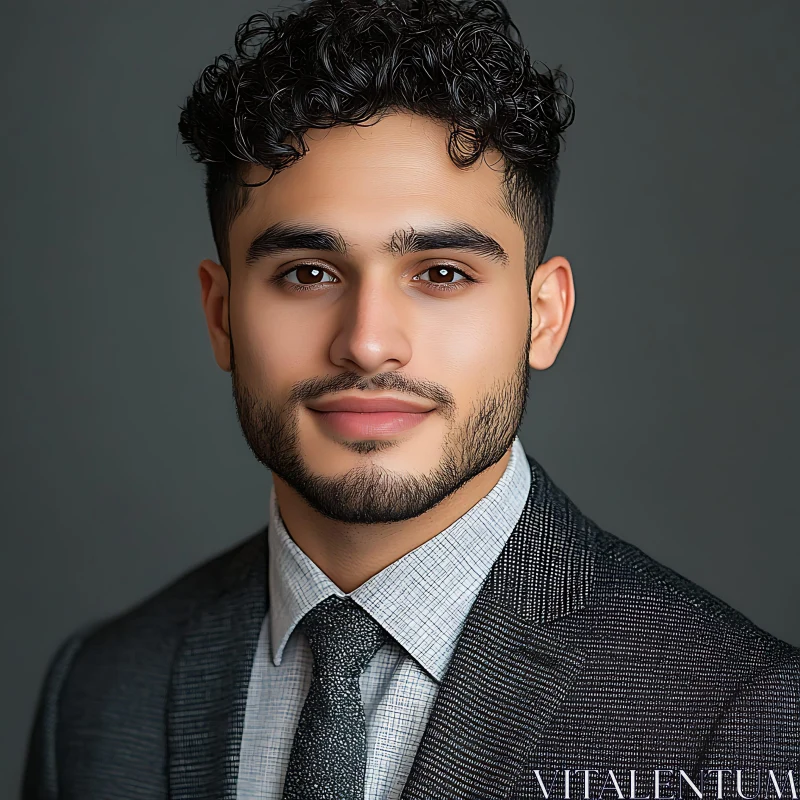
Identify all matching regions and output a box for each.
[402,456,594,800]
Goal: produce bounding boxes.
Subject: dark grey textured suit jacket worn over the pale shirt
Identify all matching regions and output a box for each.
[23,456,800,800]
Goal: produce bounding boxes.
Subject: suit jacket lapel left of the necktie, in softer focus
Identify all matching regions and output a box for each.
[167,529,267,800]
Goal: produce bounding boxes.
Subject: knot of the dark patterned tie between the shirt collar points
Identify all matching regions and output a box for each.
[300,594,389,677]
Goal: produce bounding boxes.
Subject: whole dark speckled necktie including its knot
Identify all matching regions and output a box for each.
[283,595,389,800]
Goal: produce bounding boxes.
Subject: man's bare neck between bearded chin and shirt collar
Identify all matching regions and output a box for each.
[272,448,511,592]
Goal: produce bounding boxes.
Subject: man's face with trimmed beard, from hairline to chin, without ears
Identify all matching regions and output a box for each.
[222,113,531,524]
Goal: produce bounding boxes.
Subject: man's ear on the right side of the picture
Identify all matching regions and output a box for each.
[528,256,575,369]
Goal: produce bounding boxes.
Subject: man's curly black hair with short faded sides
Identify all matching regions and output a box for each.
[178,0,574,283]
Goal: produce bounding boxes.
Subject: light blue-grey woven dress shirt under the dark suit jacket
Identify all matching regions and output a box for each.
[237,438,531,800]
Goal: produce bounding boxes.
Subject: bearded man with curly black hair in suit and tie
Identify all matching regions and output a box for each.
[24,0,800,800]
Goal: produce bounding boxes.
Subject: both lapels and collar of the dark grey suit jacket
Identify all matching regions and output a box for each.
[167,455,597,800]
